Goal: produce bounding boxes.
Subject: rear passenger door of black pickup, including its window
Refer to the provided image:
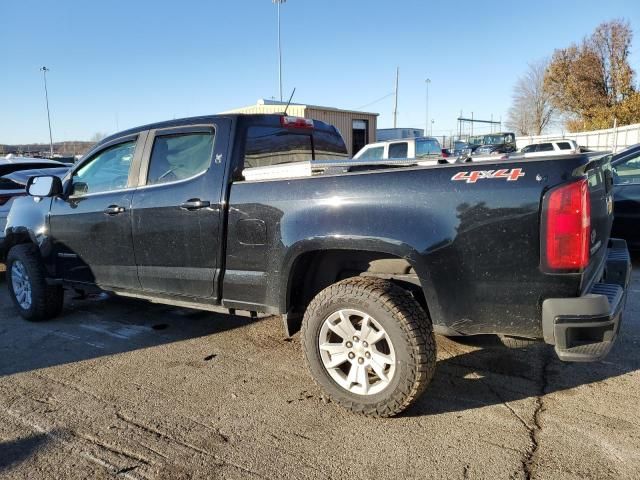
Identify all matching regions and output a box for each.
[132,119,230,298]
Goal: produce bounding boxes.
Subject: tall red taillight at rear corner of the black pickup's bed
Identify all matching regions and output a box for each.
[543,180,591,271]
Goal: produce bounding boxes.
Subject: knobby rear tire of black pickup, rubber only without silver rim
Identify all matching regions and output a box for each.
[301,277,436,417]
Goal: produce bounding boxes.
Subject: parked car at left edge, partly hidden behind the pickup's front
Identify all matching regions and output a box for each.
[0,156,62,251]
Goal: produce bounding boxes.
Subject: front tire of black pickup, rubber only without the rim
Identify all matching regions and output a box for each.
[7,244,64,322]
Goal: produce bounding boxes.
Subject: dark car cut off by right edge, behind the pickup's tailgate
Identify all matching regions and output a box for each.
[611,144,640,250]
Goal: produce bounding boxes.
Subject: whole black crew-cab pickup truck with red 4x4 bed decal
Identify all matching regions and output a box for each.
[0,115,631,416]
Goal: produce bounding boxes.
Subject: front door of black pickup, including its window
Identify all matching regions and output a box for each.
[50,134,145,289]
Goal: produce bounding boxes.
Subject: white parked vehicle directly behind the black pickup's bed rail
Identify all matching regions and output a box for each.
[353,137,447,165]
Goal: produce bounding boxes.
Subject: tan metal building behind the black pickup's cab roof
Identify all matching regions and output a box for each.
[222,99,378,156]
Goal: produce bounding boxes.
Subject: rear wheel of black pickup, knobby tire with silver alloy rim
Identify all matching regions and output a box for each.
[302,277,436,417]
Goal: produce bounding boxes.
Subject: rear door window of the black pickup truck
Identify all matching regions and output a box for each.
[147,132,213,185]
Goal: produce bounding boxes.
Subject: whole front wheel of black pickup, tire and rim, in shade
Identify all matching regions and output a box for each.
[7,244,64,321]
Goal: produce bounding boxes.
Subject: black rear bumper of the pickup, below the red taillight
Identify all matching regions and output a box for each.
[542,239,631,362]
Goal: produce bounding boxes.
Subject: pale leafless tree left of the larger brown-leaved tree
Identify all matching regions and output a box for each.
[506,59,555,135]
